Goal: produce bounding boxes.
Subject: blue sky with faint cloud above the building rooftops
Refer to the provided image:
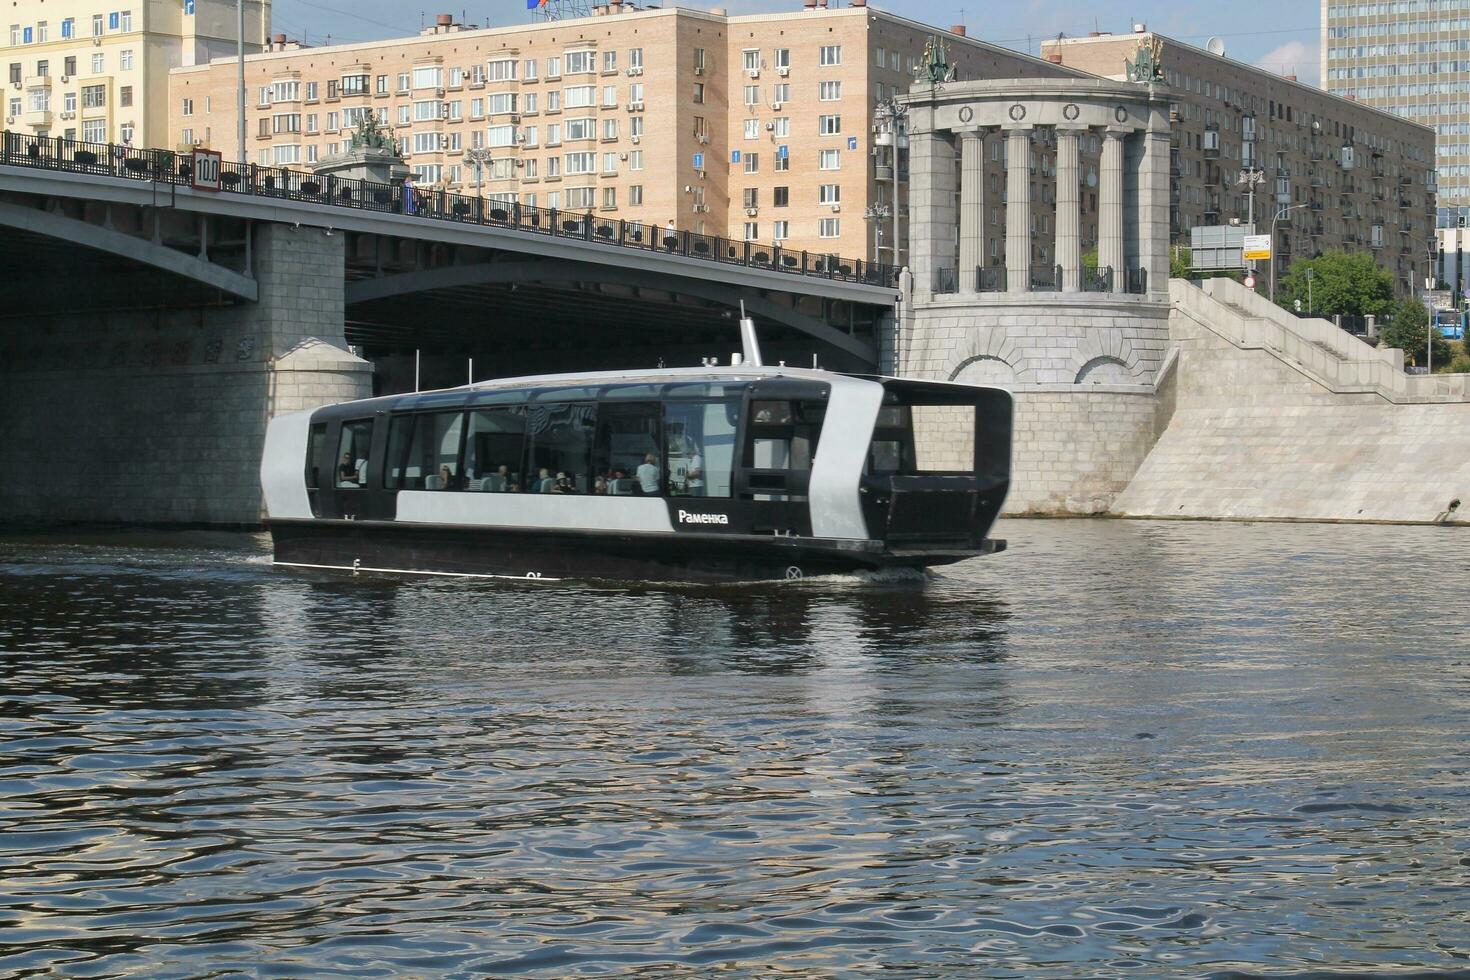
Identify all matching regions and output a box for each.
[272,0,1320,84]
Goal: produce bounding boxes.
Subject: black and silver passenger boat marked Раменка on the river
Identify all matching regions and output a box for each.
[260,325,1011,582]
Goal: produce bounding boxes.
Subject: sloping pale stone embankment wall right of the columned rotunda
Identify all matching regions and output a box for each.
[1111,279,1470,522]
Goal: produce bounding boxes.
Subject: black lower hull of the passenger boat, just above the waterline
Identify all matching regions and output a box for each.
[268,520,1005,582]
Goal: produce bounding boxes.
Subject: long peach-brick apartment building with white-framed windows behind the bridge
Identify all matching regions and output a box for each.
[168,0,1070,262]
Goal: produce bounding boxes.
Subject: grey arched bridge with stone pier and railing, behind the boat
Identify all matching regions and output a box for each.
[0,134,898,525]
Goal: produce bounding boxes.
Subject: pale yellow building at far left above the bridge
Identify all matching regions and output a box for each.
[0,0,270,145]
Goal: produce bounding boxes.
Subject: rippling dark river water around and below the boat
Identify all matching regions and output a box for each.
[0,522,1470,977]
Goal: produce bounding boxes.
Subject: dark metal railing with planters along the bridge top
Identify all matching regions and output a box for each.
[0,132,898,287]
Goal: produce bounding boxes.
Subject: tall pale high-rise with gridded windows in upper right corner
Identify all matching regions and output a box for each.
[1322,0,1470,226]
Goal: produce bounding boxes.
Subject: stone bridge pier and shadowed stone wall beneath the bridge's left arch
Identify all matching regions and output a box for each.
[0,223,372,526]
